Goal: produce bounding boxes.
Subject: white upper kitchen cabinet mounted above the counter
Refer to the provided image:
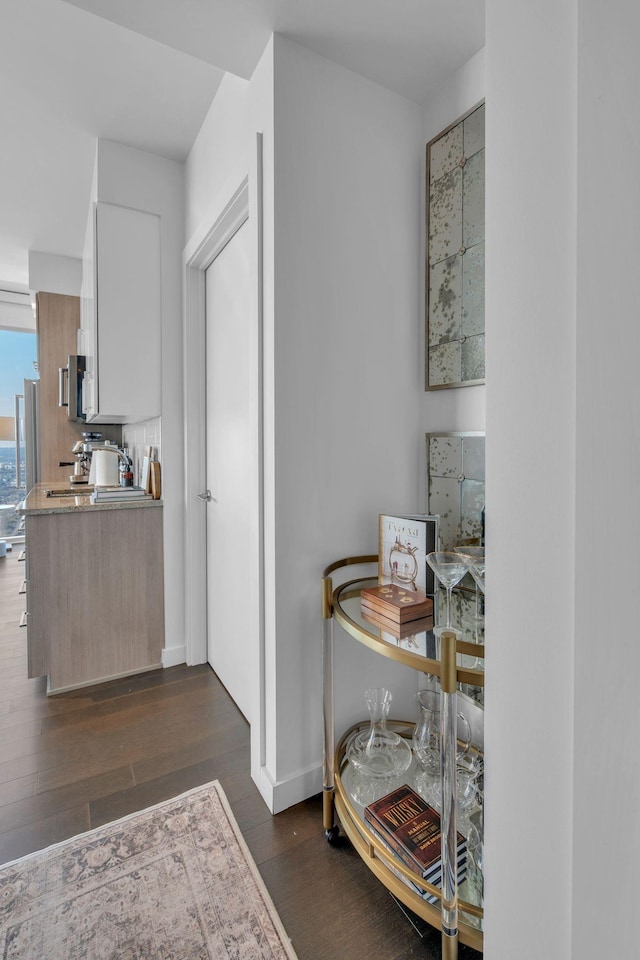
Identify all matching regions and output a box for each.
[78,201,162,423]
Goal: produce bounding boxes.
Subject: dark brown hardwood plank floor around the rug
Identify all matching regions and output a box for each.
[0,548,481,960]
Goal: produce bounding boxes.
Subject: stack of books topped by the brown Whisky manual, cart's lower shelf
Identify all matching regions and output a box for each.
[364,784,467,903]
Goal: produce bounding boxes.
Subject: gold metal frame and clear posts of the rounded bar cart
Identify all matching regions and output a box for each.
[322,554,484,960]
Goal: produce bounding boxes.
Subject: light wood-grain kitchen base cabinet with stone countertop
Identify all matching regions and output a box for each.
[23,484,164,694]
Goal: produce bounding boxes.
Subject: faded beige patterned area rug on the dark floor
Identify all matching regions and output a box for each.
[0,781,295,960]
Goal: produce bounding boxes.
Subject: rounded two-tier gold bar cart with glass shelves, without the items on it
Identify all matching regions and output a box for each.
[322,555,484,960]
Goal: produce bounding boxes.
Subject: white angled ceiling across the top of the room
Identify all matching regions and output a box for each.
[0,0,484,292]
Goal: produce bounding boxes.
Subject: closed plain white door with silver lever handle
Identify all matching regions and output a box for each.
[205,221,259,722]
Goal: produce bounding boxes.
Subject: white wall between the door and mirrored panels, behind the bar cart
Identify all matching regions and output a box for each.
[267,36,423,804]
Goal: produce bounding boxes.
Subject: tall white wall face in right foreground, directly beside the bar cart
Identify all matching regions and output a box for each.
[485,0,576,960]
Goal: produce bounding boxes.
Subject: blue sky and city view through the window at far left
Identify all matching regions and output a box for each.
[0,330,38,539]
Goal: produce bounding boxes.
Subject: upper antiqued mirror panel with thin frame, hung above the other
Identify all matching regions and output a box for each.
[425,103,485,390]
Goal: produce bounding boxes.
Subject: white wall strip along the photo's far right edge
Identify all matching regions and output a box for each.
[572,0,640,960]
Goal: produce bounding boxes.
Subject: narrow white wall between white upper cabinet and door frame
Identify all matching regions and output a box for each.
[97,140,185,666]
